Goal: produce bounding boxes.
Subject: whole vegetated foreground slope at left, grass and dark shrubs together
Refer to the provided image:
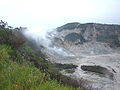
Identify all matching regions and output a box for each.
[0,21,80,90]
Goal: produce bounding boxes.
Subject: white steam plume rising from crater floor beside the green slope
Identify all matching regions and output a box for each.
[24,27,72,56]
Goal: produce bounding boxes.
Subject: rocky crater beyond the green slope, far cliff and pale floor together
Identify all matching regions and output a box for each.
[39,22,120,90]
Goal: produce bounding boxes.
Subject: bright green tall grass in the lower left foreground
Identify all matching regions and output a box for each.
[0,45,74,90]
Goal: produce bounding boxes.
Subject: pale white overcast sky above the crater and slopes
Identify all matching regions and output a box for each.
[0,0,120,28]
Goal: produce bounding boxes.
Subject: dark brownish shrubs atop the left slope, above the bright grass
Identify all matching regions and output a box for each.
[0,27,25,48]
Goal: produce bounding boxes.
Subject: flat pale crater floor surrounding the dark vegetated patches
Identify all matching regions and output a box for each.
[46,49,120,90]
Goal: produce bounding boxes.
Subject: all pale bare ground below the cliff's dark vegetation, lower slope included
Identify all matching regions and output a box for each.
[43,39,120,90]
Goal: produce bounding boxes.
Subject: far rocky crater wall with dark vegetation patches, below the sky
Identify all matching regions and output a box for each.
[52,22,120,54]
